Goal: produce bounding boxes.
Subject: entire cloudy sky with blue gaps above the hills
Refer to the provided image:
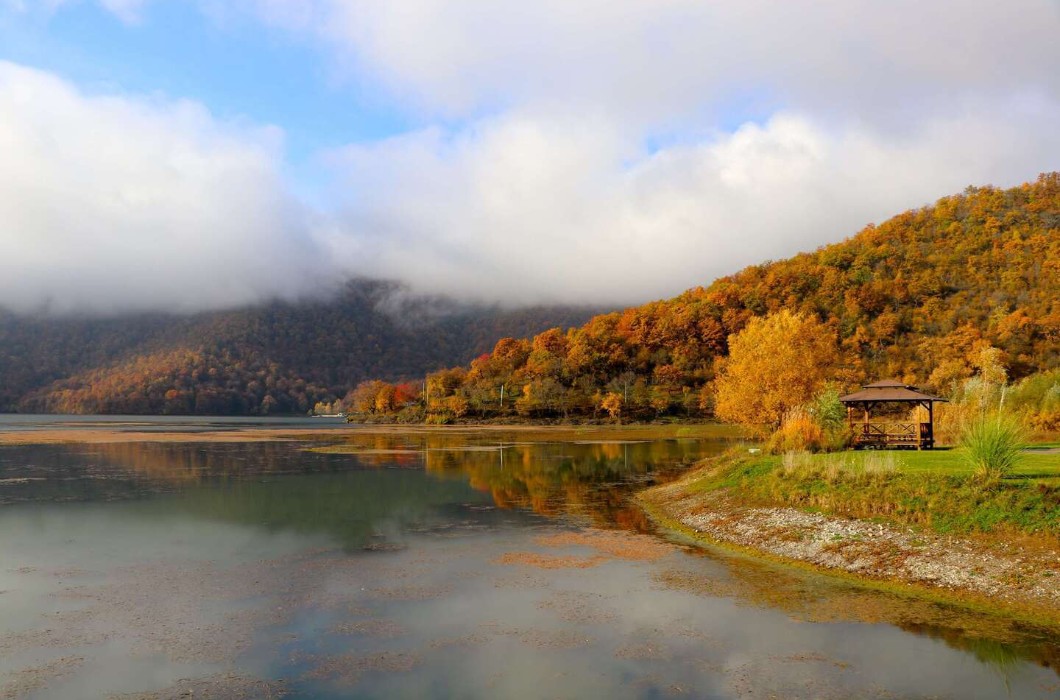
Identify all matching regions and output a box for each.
[0,0,1060,314]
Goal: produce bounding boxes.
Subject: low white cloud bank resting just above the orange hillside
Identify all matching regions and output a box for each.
[330,104,1060,303]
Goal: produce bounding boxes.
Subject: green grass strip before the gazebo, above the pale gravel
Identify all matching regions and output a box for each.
[686,450,1060,546]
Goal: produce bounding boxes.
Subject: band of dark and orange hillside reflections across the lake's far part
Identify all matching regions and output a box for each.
[0,434,724,531]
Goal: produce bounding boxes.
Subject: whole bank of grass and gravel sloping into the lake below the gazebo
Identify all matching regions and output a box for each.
[637,443,1060,629]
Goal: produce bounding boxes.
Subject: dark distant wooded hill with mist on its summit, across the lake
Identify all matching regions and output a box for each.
[0,280,606,414]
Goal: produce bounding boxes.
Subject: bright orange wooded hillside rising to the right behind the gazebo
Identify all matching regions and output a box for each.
[349,173,1060,421]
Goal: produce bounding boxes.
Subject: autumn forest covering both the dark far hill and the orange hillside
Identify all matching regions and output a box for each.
[0,173,1060,422]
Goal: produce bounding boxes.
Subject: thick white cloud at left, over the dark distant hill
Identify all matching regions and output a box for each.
[0,63,326,312]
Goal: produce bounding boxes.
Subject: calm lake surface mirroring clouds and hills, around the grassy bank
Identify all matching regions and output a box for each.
[0,419,1060,699]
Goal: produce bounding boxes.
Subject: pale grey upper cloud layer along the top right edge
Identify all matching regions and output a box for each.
[244,0,1060,126]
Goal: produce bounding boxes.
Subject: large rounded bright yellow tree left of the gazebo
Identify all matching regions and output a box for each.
[714,310,837,430]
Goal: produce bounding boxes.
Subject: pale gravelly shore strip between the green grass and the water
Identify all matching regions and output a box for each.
[638,451,1060,626]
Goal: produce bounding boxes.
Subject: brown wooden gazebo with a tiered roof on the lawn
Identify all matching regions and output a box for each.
[840,380,946,450]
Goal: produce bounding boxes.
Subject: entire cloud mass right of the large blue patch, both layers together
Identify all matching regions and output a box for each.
[250,0,1060,302]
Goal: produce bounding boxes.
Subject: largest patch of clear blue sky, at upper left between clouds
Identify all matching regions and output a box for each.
[0,1,414,163]
